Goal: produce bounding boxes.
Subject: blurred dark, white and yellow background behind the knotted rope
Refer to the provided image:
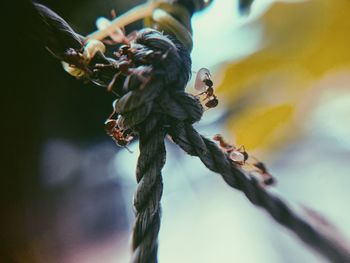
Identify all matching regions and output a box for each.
[4,0,350,263]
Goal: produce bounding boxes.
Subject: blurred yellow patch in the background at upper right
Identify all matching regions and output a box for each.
[217,0,350,150]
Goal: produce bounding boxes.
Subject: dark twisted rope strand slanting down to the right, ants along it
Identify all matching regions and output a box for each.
[169,122,350,263]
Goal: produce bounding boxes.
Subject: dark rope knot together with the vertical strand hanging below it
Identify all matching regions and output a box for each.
[115,29,197,263]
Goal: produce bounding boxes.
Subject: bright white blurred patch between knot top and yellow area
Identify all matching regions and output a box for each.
[192,0,273,71]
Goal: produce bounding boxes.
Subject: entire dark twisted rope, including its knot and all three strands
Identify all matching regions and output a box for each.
[29,2,350,263]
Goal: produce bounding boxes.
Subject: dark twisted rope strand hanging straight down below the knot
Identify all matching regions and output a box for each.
[132,115,166,263]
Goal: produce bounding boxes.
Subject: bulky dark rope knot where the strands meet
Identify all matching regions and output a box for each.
[111,29,203,135]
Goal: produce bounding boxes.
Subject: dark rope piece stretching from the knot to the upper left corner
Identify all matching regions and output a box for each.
[28,0,115,86]
